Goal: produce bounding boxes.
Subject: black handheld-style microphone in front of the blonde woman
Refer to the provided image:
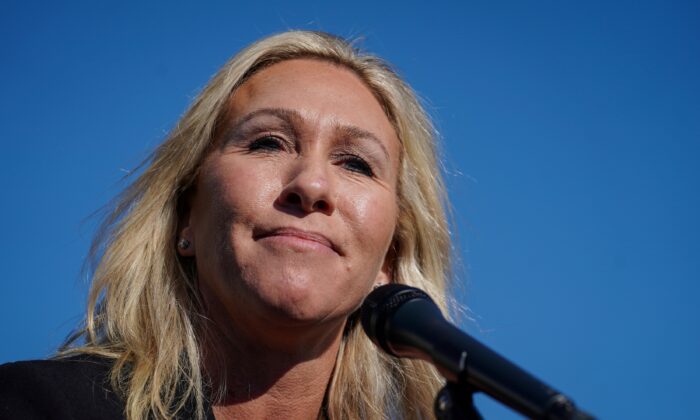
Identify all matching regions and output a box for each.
[361,284,593,420]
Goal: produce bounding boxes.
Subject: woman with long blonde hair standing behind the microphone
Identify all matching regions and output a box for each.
[0,31,449,419]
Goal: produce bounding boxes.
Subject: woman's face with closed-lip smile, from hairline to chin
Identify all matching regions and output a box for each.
[179,59,400,338]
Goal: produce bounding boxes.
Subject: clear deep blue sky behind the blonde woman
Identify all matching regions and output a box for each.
[0,0,700,419]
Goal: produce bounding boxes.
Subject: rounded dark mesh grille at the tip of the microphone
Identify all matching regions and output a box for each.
[361,283,433,356]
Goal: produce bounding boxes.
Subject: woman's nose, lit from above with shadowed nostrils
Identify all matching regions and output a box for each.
[278,159,335,215]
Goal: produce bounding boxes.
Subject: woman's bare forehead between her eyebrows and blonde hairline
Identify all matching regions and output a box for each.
[221,59,400,154]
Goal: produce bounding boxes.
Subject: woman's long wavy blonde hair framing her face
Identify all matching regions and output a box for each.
[58,31,450,419]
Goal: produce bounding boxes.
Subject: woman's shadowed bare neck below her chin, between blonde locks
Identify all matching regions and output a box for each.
[204,306,344,419]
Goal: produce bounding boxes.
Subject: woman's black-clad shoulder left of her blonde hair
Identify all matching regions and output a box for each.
[0,356,124,420]
